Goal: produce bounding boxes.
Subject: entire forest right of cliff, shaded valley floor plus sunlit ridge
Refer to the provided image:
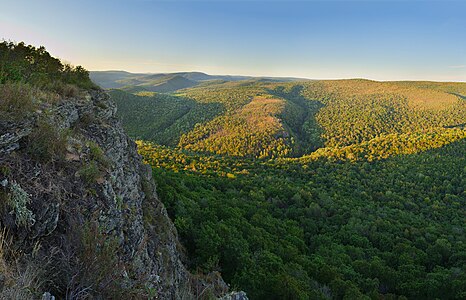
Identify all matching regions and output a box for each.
[105,74,466,299]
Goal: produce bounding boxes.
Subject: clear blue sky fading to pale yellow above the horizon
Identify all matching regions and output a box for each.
[0,0,466,81]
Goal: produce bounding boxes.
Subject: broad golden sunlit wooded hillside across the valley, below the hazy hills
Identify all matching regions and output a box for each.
[111,80,466,158]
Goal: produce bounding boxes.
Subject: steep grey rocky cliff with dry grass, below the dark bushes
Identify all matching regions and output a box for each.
[0,91,217,299]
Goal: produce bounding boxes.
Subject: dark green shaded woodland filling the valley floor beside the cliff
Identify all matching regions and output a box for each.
[139,139,466,299]
